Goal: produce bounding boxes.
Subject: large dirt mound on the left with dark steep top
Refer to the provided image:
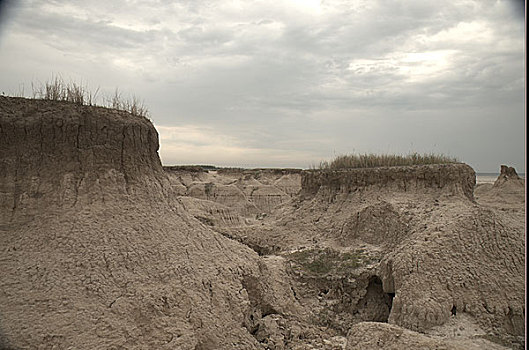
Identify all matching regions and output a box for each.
[0,97,268,349]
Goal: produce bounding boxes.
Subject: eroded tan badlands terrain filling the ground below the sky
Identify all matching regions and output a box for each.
[0,97,525,350]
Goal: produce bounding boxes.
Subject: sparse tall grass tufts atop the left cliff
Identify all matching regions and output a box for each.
[13,76,149,118]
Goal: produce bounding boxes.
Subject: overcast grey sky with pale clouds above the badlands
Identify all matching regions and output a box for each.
[0,0,526,173]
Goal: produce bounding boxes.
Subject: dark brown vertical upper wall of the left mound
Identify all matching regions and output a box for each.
[0,97,162,219]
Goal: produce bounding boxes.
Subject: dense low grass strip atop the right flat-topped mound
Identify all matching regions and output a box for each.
[319,153,459,170]
